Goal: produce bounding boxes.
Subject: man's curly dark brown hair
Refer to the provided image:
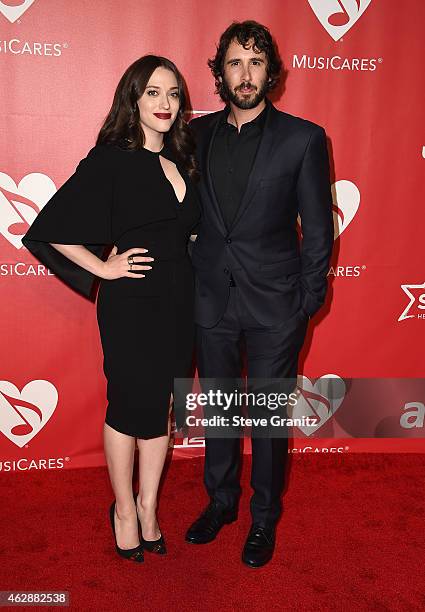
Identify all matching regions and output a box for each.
[208,21,282,102]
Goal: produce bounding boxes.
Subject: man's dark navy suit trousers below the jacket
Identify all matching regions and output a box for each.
[197,287,308,526]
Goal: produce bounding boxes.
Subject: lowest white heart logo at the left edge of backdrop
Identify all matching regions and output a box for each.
[0,380,58,448]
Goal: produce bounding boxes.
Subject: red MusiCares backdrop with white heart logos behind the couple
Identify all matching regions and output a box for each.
[0,0,425,471]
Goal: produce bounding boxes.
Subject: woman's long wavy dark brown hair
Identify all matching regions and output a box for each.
[96,55,197,178]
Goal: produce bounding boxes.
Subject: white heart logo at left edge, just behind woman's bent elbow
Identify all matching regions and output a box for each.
[0,172,56,249]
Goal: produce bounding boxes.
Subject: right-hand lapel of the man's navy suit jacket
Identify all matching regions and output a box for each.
[230,100,277,229]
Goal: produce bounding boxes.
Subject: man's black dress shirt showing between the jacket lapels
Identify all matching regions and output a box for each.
[210,108,266,229]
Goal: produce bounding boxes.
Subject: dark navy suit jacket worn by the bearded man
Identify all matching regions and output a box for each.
[190,101,334,327]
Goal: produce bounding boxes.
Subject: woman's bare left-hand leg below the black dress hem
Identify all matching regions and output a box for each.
[103,423,140,549]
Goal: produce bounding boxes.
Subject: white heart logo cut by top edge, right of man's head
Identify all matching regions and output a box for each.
[308,0,372,41]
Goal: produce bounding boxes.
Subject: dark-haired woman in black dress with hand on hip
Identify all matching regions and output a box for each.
[23,55,199,562]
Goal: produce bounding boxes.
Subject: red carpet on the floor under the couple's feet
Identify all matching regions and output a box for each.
[0,454,425,612]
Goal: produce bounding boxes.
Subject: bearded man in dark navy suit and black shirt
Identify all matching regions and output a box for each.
[186,21,333,567]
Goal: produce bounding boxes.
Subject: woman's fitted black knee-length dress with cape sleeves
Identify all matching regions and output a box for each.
[22,145,200,438]
